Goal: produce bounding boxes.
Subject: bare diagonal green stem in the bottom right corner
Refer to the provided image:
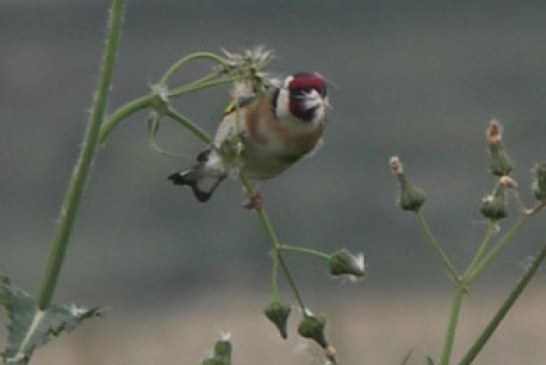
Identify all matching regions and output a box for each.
[459,246,546,365]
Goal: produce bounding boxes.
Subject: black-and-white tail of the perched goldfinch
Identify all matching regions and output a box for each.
[169,151,226,202]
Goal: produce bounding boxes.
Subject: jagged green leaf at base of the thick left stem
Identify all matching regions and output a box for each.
[0,275,102,365]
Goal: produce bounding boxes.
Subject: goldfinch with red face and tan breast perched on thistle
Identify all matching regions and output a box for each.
[169,72,329,207]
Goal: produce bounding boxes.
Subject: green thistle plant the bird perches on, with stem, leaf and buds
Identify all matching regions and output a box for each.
[0,0,364,365]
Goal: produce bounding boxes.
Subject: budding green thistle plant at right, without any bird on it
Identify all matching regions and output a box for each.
[390,120,546,365]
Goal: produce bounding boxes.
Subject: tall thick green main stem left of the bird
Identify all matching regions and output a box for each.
[38,0,125,310]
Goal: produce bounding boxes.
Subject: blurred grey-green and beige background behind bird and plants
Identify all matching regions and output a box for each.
[0,0,546,365]
